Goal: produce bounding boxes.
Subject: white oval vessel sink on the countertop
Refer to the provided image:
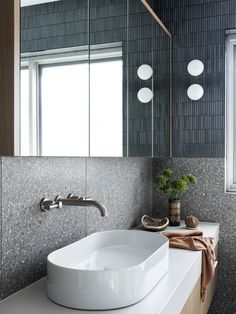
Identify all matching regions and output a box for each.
[47,230,169,310]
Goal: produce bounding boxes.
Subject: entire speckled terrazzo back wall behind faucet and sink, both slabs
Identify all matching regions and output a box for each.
[0,157,152,297]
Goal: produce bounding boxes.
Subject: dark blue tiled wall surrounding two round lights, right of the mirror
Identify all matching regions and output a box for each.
[155,0,236,157]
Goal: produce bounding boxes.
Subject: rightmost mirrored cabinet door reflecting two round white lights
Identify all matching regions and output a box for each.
[127,1,170,157]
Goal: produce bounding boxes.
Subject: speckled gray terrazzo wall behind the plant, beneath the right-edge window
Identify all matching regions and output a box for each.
[153,158,236,314]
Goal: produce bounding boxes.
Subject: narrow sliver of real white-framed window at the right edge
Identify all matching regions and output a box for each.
[225,34,236,193]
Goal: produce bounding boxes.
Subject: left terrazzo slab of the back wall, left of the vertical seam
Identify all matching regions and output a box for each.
[2,157,86,297]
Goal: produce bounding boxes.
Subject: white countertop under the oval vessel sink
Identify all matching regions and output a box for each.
[0,223,219,314]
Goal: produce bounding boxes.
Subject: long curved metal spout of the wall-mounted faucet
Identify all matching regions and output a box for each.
[61,194,107,217]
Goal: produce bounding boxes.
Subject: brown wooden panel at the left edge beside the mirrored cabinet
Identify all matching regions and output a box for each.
[0,0,20,156]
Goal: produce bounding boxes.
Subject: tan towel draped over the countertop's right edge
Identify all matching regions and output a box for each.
[162,230,215,301]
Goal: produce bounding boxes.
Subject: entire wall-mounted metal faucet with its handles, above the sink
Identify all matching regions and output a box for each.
[39,194,107,217]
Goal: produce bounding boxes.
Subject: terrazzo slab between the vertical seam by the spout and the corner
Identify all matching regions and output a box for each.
[87,158,152,233]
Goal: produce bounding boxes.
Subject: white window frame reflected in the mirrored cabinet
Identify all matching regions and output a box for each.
[19,42,122,156]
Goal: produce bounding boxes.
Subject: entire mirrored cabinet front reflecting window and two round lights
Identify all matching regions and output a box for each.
[17,0,171,157]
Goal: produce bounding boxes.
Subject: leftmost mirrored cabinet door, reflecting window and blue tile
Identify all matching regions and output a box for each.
[19,0,89,156]
